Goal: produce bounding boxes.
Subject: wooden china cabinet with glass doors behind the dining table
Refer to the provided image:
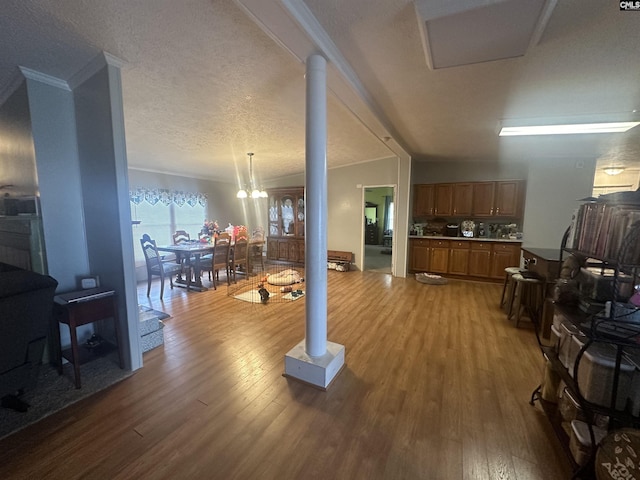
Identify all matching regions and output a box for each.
[267,187,306,263]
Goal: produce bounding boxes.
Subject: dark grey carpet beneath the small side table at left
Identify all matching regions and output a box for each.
[0,352,133,439]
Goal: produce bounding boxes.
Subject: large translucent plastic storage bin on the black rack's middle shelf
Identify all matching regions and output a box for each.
[571,337,635,410]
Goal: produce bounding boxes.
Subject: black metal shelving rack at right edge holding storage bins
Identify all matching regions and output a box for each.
[530,198,640,478]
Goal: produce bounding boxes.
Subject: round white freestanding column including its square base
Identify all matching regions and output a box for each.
[285,55,344,389]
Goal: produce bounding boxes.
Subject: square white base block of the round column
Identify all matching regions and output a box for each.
[284,339,344,390]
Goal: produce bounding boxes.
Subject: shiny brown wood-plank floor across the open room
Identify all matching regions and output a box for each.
[0,271,571,480]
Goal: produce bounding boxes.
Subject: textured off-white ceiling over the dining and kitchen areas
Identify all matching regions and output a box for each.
[0,0,640,181]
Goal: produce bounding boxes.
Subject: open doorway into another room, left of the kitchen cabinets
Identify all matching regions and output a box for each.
[362,185,395,274]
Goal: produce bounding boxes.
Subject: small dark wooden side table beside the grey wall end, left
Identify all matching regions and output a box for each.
[54,288,124,388]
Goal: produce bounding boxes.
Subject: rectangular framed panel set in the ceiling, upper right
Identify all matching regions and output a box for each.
[414,0,557,70]
